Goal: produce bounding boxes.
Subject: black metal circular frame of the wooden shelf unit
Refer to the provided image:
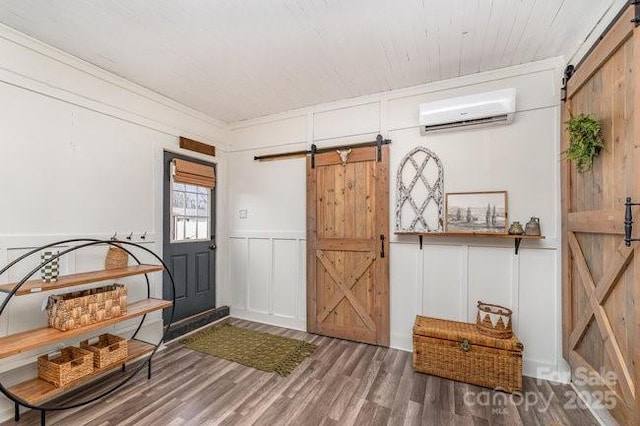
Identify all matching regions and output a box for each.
[0,238,176,426]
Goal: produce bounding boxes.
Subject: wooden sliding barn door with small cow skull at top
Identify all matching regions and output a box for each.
[307,146,389,346]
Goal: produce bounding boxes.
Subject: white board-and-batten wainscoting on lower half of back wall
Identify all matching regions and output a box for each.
[229,232,560,380]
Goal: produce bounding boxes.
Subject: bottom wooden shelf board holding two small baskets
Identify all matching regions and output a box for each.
[9,340,155,405]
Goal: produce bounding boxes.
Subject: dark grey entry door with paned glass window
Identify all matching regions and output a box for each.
[162,152,216,323]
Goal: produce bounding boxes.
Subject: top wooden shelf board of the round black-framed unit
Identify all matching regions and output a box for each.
[0,265,164,296]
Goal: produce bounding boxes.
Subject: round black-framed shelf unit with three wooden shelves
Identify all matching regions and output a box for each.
[0,239,175,425]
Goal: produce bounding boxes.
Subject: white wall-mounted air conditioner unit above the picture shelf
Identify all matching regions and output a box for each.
[420,89,516,132]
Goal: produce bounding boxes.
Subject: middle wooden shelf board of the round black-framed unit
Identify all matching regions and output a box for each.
[0,299,172,359]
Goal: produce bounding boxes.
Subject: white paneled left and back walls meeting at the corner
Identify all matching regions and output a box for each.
[0,23,566,426]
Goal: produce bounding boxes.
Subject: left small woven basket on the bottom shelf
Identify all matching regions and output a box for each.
[38,346,93,387]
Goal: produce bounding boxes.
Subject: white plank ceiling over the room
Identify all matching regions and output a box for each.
[0,0,614,123]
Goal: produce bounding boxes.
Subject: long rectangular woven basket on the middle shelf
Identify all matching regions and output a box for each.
[47,284,127,331]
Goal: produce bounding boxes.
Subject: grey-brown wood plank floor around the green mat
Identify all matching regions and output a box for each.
[0,320,597,426]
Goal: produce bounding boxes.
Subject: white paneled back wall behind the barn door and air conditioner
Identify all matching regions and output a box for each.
[228,59,567,380]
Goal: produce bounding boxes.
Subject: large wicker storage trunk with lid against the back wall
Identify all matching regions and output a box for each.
[413,315,523,392]
